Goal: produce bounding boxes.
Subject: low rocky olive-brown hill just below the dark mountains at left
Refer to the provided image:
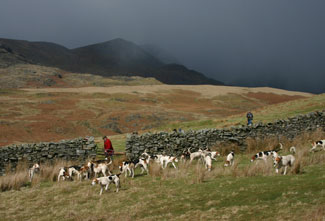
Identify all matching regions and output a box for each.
[0,64,161,89]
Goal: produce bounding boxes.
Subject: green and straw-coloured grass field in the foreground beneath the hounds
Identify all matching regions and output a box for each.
[0,131,325,220]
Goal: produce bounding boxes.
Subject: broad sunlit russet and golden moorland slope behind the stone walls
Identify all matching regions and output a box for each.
[0,85,316,146]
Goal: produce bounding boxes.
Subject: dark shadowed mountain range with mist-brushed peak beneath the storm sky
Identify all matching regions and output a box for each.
[0,39,223,85]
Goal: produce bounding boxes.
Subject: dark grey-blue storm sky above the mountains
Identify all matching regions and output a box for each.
[0,0,325,92]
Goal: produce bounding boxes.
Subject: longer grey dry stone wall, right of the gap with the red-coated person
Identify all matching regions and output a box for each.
[125,110,325,159]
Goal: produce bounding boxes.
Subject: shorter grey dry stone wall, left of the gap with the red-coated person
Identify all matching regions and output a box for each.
[0,137,97,175]
